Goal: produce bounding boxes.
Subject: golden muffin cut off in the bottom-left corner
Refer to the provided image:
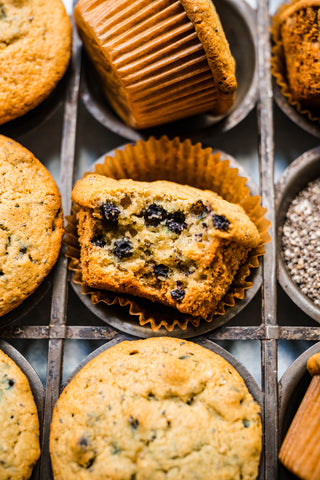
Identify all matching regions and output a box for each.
[0,350,40,480]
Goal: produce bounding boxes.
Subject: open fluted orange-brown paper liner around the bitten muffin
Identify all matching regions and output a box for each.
[65,136,270,331]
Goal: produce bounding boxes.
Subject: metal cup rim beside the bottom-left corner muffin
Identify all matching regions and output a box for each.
[0,340,44,480]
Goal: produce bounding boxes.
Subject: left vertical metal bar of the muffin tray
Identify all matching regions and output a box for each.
[40,25,81,479]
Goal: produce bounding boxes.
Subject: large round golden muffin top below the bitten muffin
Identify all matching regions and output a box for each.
[50,338,262,480]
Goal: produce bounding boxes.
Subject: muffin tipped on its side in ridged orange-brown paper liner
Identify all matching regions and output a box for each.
[74,0,237,129]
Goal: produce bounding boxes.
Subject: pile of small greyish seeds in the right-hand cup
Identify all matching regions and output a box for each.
[282,177,320,305]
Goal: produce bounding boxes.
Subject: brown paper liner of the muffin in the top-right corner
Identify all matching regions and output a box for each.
[271,0,320,123]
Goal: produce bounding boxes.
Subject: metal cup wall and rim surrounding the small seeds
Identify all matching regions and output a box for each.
[276,147,320,323]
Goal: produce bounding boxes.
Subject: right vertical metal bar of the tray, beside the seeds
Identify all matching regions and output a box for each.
[257,0,278,480]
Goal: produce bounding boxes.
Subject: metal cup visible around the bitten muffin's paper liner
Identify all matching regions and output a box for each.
[71,145,262,338]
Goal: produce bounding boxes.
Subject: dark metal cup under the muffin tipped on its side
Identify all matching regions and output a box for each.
[80,0,258,141]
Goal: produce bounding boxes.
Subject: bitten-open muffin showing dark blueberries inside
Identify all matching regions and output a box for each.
[72,174,261,318]
